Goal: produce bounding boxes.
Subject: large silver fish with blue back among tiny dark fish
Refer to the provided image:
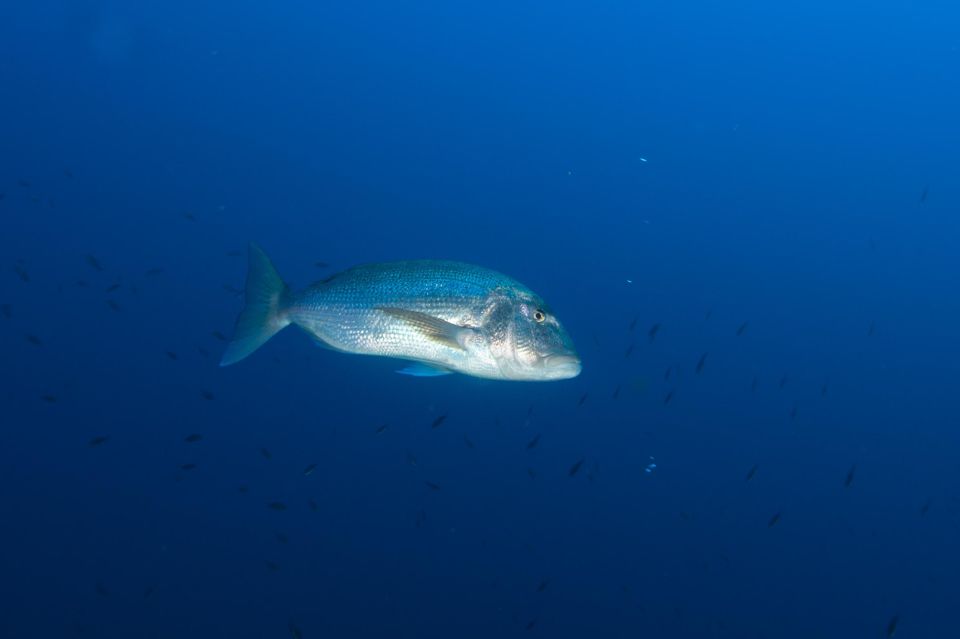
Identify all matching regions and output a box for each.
[220,244,580,381]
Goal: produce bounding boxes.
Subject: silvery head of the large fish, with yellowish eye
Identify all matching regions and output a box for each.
[482,289,581,381]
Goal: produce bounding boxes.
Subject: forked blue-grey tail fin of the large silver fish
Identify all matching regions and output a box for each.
[220,242,290,366]
